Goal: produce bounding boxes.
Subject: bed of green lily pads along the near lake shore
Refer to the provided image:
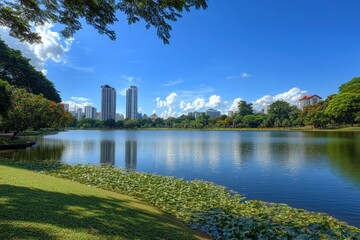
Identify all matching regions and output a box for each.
[38,165,360,239]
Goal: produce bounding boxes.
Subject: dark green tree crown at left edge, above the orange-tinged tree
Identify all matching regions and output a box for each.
[0,39,61,102]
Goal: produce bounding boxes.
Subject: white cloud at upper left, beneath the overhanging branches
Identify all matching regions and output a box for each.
[0,23,74,73]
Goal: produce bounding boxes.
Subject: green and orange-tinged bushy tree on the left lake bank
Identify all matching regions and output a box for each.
[1,85,72,135]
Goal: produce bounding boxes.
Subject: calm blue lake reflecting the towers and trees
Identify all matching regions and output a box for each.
[0,130,360,227]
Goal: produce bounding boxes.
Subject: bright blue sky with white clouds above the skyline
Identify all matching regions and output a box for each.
[0,0,360,118]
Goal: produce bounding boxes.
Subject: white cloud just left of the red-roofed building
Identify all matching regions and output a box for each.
[253,87,307,110]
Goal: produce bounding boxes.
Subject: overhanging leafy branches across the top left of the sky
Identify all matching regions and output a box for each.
[0,0,207,43]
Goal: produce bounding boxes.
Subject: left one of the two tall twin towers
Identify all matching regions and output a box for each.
[101,85,116,121]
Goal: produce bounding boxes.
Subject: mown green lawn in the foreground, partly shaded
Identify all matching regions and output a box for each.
[0,164,208,240]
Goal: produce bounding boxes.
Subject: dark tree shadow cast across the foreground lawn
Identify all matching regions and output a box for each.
[0,185,197,239]
